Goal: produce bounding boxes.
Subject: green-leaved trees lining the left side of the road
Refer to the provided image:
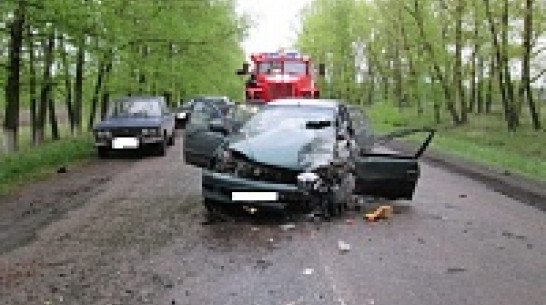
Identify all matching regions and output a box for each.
[0,0,246,149]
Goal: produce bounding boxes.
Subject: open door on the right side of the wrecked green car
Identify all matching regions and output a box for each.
[355,128,435,200]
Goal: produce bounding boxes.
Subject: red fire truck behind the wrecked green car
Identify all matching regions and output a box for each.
[237,51,324,102]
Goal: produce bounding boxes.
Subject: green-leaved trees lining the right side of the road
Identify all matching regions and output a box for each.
[297,0,546,131]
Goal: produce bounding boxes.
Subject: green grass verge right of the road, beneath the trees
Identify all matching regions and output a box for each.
[367,103,546,181]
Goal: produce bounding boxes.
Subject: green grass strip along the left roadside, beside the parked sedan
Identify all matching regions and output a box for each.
[0,133,95,195]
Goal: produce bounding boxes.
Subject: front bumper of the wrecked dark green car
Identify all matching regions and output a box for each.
[202,170,305,209]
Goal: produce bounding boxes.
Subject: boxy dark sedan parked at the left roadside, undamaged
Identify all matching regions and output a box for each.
[93,96,175,157]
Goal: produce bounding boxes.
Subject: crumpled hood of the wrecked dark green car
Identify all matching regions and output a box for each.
[228,127,335,171]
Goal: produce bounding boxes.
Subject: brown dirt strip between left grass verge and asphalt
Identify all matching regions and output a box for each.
[0,160,135,254]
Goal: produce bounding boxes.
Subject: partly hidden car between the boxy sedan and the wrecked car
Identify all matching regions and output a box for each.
[173,96,233,128]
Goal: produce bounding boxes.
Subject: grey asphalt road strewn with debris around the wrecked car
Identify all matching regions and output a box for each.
[0,134,546,305]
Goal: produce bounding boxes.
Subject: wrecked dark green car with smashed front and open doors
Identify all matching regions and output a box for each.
[184,99,434,217]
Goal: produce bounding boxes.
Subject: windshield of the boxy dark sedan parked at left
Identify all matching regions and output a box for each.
[108,100,161,118]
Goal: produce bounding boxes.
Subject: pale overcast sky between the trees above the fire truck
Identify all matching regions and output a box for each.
[237,0,312,55]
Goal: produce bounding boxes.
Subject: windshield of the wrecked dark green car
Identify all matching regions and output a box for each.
[240,106,334,136]
